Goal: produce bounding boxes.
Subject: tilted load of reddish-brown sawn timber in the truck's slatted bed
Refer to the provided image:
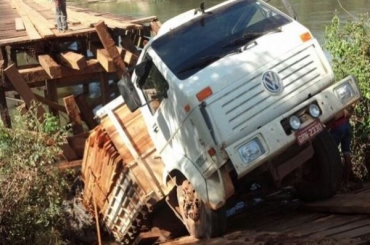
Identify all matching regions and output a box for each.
[82,97,173,244]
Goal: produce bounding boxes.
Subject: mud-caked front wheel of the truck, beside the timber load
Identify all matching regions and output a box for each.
[177,180,226,238]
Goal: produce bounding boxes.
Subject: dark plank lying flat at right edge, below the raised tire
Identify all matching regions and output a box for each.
[303,193,370,214]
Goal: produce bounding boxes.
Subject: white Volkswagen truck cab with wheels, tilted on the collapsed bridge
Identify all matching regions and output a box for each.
[81,0,361,241]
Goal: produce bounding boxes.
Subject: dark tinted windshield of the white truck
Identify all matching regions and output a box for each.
[152,0,291,80]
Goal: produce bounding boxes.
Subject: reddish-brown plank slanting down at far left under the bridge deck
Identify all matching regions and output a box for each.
[4,64,45,118]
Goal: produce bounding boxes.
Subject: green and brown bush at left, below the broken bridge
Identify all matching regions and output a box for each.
[0,101,69,244]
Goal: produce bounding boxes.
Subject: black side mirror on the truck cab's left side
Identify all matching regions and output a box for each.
[117,73,141,112]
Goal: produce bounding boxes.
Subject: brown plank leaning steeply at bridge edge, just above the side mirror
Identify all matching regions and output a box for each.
[95,21,126,77]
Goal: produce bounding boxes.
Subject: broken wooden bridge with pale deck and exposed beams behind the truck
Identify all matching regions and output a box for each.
[0,0,161,161]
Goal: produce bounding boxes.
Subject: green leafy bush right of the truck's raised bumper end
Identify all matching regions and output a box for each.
[324,11,370,179]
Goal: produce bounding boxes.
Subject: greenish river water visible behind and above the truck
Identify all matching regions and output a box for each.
[77,0,370,44]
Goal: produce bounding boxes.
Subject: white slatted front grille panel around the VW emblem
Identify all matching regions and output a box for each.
[210,46,326,139]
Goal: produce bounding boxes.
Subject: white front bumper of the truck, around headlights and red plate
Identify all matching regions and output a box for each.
[225,76,361,177]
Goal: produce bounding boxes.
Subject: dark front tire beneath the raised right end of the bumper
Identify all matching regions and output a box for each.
[295,130,343,202]
